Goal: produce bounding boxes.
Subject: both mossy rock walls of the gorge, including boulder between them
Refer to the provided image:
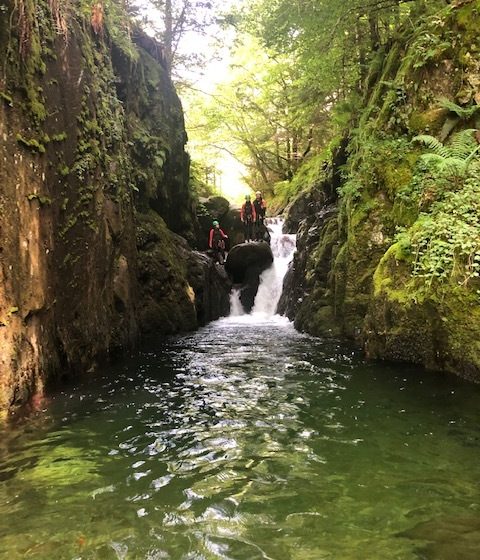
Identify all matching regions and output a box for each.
[0,0,480,412]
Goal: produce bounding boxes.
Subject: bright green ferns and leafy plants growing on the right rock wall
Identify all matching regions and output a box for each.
[397,130,480,289]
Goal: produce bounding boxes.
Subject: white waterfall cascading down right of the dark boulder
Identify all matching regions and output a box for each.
[252,218,296,317]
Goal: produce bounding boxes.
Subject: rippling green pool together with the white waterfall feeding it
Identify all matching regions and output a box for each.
[0,225,480,560]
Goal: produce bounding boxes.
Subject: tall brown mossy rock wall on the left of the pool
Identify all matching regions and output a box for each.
[0,0,204,411]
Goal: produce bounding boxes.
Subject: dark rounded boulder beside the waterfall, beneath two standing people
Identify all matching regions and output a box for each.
[225,242,273,312]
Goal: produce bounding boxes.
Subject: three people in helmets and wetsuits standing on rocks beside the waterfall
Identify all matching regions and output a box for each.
[208,191,270,264]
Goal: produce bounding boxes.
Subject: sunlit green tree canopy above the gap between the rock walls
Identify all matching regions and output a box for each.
[184,0,445,202]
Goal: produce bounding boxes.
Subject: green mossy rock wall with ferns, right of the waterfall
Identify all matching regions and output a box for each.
[283,1,480,381]
